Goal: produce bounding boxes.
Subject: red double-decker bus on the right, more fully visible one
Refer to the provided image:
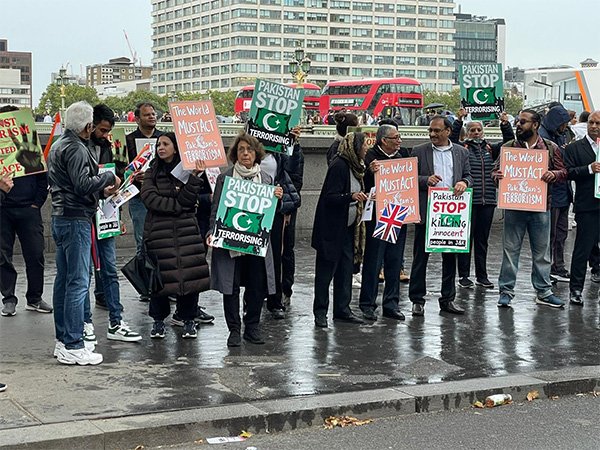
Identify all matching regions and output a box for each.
[319,78,423,125]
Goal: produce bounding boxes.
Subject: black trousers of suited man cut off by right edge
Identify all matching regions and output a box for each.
[569,211,600,292]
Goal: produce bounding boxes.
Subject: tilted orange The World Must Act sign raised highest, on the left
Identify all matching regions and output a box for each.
[169,100,227,170]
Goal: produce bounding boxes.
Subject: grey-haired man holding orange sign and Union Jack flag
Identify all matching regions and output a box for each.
[359,124,408,320]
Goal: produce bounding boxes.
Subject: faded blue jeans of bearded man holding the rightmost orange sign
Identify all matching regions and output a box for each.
[498,210,552,298]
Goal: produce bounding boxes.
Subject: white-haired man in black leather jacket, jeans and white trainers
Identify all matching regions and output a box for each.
[48,101,121,365]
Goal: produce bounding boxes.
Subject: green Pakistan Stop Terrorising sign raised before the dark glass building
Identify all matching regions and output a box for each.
[458,63,504,120]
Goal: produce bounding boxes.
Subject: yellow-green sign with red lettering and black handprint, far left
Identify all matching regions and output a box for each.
[0,109,46,178]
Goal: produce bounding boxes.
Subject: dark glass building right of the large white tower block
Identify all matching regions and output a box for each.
[454,12,506,82]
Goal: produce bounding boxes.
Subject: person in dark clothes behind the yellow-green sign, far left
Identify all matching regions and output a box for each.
[0,106,52,316]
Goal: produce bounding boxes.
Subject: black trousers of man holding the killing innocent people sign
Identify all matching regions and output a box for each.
[408,225,456,305]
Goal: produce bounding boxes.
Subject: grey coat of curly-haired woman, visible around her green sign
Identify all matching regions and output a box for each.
[207,167,275,295]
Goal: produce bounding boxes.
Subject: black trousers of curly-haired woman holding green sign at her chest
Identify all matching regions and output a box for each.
[223,255,268,333]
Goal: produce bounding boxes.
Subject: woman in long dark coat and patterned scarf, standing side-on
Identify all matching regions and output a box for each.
[311,133,367,328]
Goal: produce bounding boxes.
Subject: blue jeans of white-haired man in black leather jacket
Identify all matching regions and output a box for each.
[52,217,92,350]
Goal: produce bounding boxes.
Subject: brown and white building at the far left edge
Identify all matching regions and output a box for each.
[0,39,32,108]
